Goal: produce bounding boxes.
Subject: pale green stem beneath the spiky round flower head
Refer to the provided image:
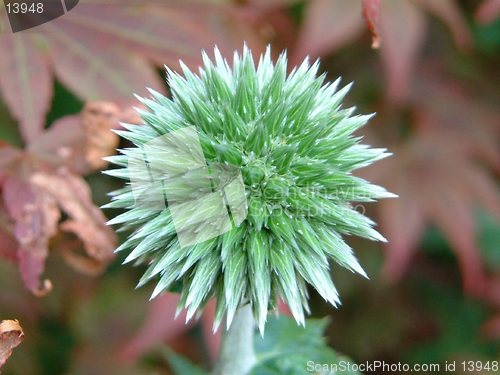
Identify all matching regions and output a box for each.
[213,304,256,375]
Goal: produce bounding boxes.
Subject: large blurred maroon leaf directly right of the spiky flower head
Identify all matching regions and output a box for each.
[363,67,500,297]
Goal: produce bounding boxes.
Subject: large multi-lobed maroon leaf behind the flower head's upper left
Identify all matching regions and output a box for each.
[0,0,262,143]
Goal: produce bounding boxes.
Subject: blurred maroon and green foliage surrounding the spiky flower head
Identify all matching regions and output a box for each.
[0,0,500,375]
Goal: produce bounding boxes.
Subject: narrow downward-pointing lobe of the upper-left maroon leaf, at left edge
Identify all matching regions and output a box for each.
[0,33,52,142]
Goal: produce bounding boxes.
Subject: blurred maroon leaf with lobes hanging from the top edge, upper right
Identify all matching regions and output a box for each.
[292,0,472,104]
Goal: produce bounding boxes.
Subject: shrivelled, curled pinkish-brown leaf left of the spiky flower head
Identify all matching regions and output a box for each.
[0,102,124,296]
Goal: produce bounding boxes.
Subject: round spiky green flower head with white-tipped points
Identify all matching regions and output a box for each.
[106,47,394,331]
